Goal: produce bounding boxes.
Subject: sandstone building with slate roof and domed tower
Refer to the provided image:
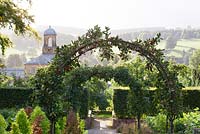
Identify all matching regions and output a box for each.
[24,26,57,75]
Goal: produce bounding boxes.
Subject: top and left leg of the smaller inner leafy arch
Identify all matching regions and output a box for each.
[63,66,135,118]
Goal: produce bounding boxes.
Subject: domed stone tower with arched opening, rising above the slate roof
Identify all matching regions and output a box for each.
[42,26,57,54]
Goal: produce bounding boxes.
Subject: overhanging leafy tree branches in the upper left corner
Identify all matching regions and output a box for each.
[0,0,39,54]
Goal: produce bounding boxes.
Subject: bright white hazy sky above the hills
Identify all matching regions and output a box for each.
[30,0,200,29]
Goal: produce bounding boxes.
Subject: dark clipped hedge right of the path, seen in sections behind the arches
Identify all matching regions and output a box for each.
[113,89,200,118]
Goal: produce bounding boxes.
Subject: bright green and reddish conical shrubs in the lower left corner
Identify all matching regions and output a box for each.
[0,106,85,134]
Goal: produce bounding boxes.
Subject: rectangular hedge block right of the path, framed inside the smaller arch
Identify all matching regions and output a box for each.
[113,89,129,118]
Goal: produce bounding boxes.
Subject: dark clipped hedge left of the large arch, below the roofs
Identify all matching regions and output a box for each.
[0,88,33,109]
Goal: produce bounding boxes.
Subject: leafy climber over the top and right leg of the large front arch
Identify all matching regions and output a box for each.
[33,26,181,133]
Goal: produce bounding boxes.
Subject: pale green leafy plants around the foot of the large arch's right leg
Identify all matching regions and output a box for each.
[145,108,200,134]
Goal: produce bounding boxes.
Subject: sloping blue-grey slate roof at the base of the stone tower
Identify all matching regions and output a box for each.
[25,54,55,65]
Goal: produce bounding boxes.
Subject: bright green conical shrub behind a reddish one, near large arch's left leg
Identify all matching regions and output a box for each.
[30,106,50,134]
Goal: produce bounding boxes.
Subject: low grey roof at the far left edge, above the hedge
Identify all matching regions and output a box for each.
[1,68,25,78]
